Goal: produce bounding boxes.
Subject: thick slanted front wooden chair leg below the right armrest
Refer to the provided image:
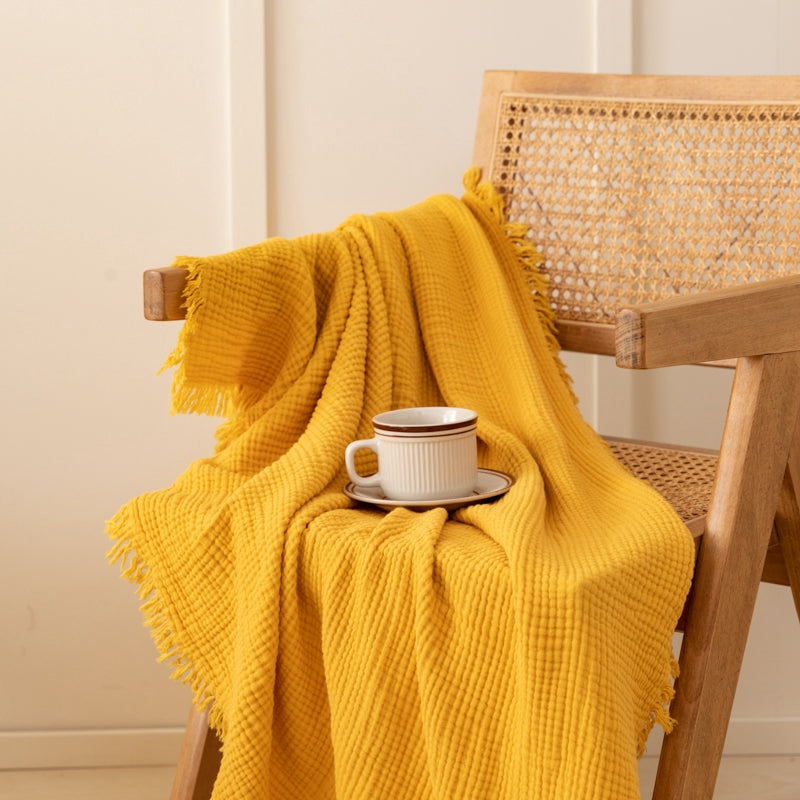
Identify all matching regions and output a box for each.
[653,354,800,800]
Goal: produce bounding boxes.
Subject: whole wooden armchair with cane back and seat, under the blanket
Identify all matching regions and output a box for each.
[145,72,800,800]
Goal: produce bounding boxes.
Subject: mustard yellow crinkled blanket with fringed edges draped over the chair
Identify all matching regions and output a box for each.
[108,173,694,800]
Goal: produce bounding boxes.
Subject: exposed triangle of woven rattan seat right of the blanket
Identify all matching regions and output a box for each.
[606,438,717,536]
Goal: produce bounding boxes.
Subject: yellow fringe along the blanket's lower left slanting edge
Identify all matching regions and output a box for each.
[106,517,225,741]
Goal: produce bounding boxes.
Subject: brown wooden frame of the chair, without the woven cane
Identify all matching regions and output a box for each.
[145,72,800,800]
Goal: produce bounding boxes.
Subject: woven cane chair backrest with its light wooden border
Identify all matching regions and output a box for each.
[476,73,800,352]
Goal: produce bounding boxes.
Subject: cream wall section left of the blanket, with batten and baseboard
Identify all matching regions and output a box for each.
[0,0,266,766]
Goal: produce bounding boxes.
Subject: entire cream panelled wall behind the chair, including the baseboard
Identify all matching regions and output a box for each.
[0,0,800,766]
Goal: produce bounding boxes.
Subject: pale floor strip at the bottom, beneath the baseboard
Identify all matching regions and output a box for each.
[0,756,800,800]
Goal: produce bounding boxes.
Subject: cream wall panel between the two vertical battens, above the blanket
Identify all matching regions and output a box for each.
[268,0,593,236]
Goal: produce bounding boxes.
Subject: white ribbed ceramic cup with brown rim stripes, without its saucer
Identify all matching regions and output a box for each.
[345,406,478,500]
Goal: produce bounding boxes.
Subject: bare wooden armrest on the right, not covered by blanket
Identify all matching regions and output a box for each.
[616,275,800,369]
